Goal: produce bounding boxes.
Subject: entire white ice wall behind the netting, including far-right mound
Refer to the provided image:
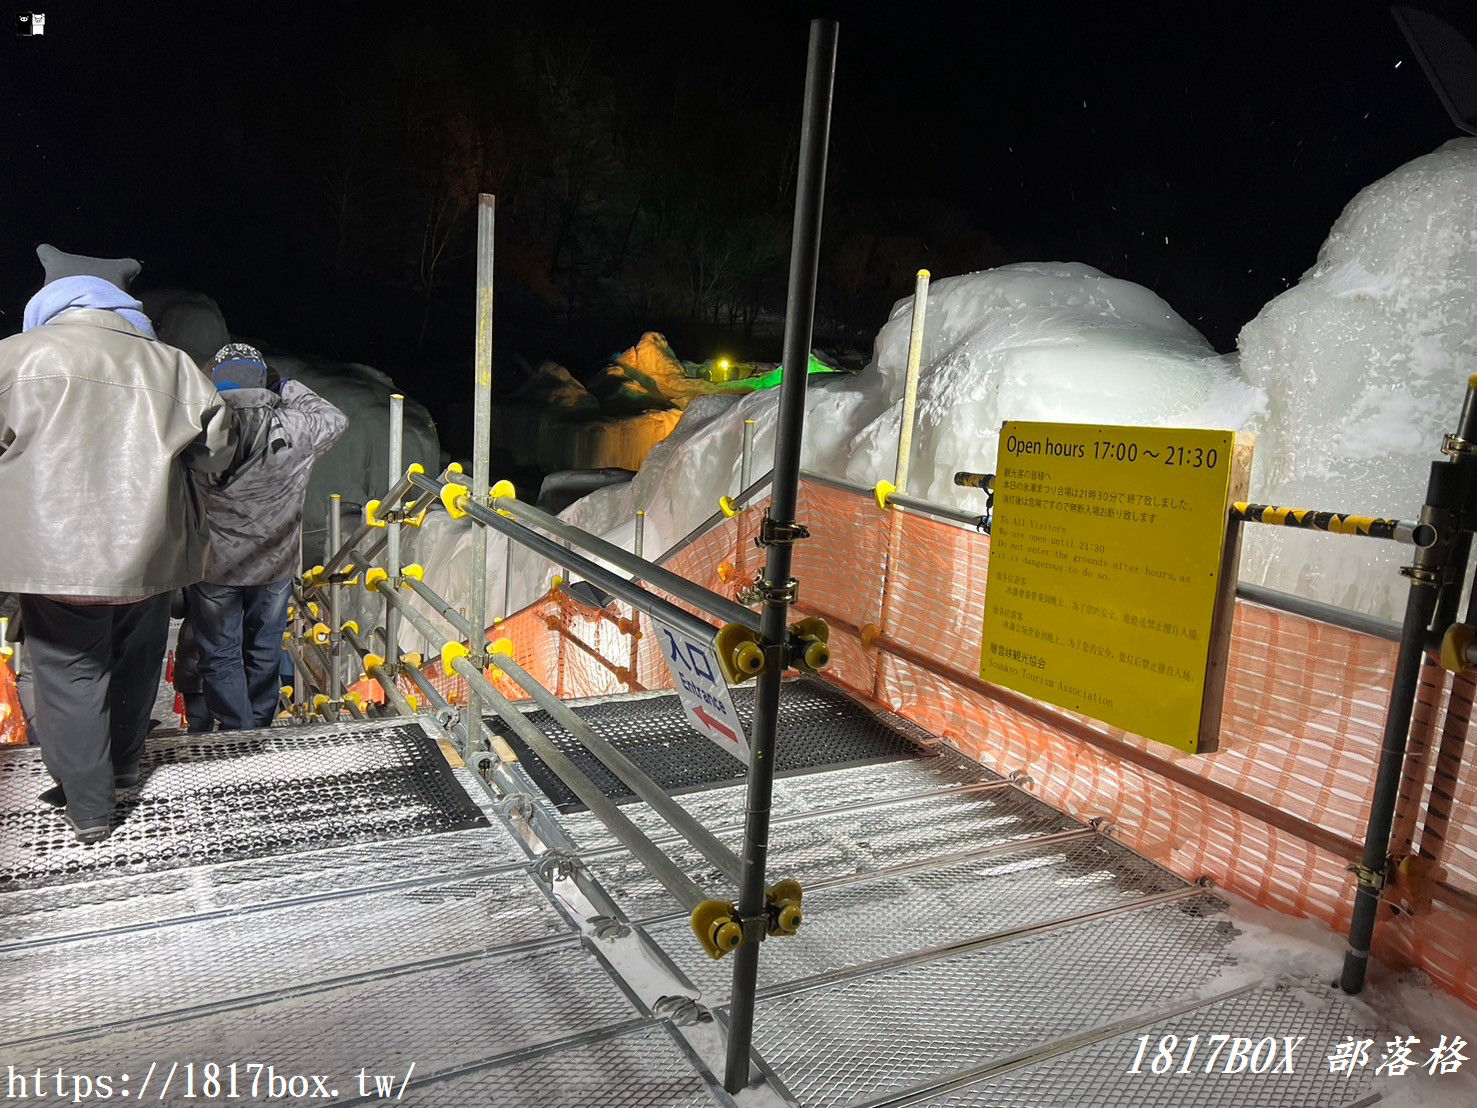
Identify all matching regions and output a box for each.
[410,139,1477,638]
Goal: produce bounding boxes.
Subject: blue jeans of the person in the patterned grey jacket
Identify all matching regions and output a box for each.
[185,581,292,731]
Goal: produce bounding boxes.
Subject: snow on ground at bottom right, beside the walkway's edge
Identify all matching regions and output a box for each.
[1205,889,1477,1108]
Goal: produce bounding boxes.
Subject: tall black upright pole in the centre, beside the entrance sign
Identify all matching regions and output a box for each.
[724,19,836,1093]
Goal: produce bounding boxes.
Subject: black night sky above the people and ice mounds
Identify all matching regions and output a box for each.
[0,0,1458,452]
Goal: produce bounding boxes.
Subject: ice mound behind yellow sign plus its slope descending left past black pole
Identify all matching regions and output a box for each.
[395,263,1264,641]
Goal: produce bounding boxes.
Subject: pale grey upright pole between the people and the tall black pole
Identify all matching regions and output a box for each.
[465,192,507,755]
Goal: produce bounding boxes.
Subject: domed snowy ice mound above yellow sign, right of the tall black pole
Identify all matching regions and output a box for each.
[838,263,1264,507]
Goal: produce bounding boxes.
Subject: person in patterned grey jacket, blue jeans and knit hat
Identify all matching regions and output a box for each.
[185,343,349,731]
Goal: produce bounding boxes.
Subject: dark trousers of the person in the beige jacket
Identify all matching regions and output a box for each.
[21,592,170,821]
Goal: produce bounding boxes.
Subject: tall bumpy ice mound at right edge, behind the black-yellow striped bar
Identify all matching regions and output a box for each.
[1241,139,1477,619]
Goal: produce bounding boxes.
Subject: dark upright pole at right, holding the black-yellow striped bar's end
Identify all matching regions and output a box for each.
[1338,375,1477,993]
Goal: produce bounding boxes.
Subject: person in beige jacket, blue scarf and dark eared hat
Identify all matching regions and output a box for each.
[0,247,236,842]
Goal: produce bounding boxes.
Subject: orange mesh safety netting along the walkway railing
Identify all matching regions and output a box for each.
[357,483,1477,1003]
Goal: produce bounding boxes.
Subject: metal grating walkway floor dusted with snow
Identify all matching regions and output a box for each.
[0,684,1429,1108]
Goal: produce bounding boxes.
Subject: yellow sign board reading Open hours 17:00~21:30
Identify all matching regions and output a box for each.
[979,421,1250,752]
